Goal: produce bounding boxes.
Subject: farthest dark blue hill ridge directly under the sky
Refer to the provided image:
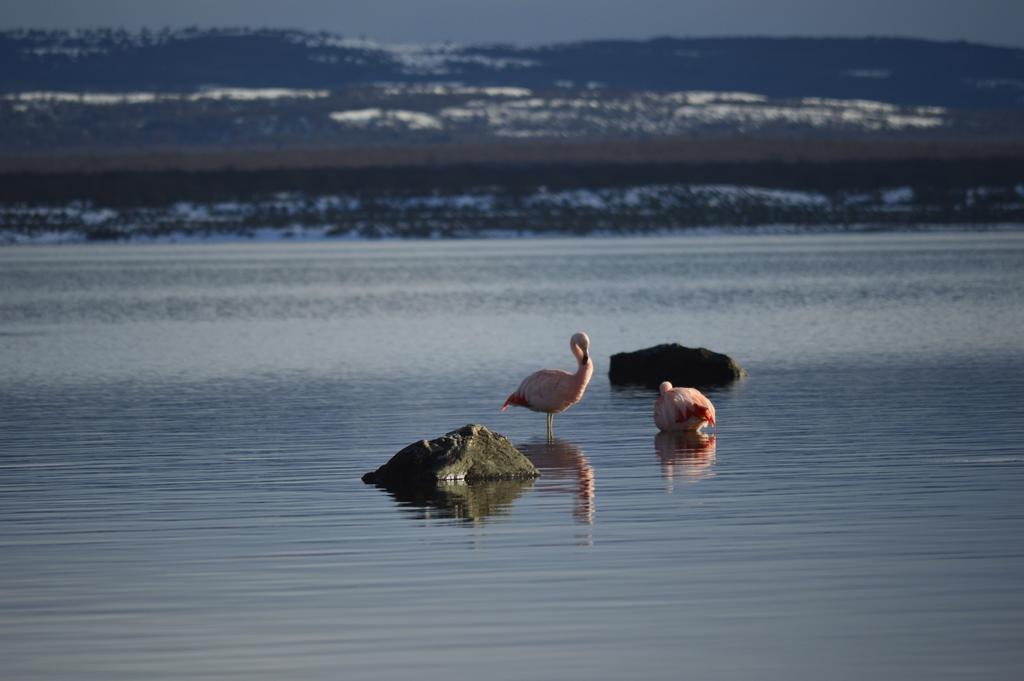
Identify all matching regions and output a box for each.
[6,29,1024,109]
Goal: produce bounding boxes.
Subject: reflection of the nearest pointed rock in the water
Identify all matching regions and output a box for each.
[376,479,534,523]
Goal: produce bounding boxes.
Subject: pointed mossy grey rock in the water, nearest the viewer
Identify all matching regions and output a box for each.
[362,424,541,487]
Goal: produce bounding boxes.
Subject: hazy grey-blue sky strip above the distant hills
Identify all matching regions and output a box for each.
[0,0,1024,47]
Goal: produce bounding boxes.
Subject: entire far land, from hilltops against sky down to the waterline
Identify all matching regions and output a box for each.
[0,29,1024,245]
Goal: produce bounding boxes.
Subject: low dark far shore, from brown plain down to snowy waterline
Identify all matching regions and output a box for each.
[8,138,1024,243]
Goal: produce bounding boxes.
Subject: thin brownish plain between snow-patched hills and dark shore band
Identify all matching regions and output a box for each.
[0,135,1024,175]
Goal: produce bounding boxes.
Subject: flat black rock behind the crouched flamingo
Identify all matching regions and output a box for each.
[608,343,746,388]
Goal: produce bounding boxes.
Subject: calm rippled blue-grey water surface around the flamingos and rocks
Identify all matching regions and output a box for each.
[0,232,1024,680]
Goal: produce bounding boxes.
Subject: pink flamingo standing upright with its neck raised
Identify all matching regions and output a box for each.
[501,331,594,439]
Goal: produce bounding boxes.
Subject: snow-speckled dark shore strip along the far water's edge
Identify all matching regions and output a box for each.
[0,175,1024,243]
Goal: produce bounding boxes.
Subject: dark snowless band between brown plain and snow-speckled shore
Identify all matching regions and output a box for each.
[6,156,1024,207]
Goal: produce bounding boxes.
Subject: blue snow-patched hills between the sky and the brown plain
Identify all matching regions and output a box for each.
[0,29,1024,153]
